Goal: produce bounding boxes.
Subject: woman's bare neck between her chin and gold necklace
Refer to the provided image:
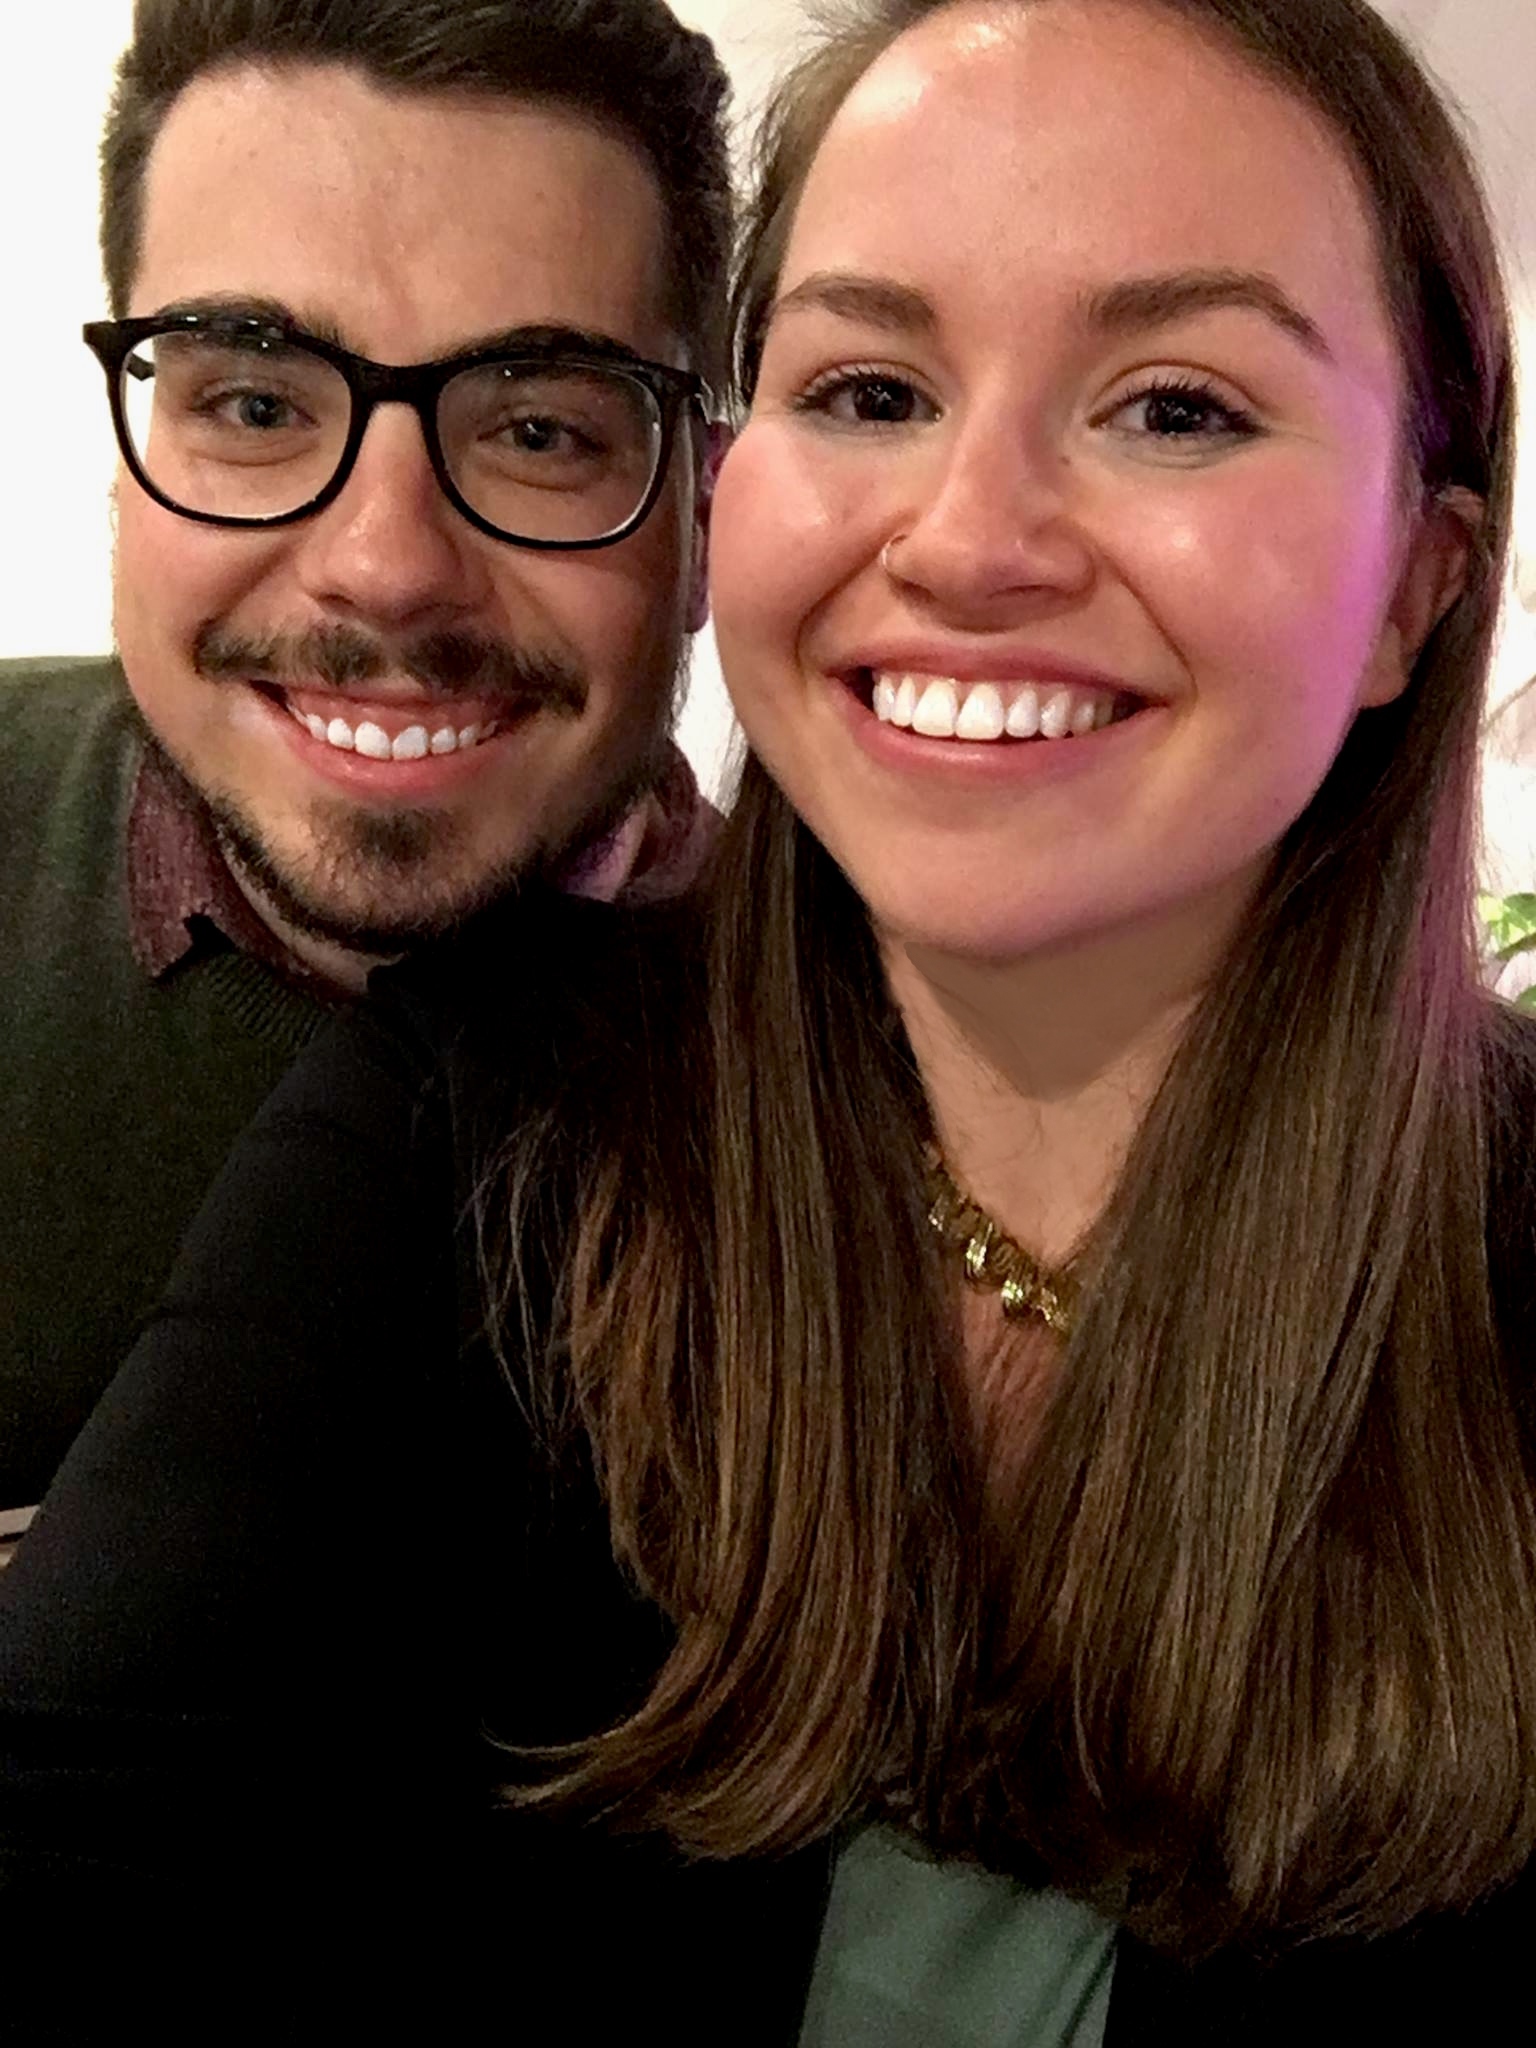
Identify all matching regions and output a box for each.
[883,903,1235,1266]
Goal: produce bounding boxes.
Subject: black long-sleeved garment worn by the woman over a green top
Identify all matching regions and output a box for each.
[0,901,1536,2048]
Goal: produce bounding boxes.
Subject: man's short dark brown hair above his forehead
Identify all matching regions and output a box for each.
[100,0,731,383]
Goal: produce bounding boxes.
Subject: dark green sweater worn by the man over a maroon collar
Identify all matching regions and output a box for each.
[0,662,326,1509]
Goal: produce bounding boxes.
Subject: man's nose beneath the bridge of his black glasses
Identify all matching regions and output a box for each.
[295,403,485,627]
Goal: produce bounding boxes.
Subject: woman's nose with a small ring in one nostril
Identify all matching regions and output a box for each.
[881,412,1096,625]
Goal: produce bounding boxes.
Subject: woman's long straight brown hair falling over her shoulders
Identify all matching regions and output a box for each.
[489,0,1536,1954]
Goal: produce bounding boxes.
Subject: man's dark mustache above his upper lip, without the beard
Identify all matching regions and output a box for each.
[193,621,586,717]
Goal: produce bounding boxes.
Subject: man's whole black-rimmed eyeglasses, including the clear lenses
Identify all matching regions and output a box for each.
[84,313,711,549]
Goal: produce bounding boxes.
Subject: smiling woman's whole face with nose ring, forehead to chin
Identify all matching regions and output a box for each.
[713,0,1454,958]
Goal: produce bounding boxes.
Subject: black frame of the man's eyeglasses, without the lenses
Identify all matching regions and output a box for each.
[80,313,713,553]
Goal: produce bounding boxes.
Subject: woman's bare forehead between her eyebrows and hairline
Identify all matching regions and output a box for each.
[780,0,1397,382]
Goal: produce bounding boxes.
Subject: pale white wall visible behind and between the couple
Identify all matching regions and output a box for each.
[0,0,1536,864]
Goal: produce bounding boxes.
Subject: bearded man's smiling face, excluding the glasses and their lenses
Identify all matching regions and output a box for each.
[115,66,696,952]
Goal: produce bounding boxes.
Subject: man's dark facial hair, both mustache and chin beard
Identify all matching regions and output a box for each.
[162,625,684,956]
